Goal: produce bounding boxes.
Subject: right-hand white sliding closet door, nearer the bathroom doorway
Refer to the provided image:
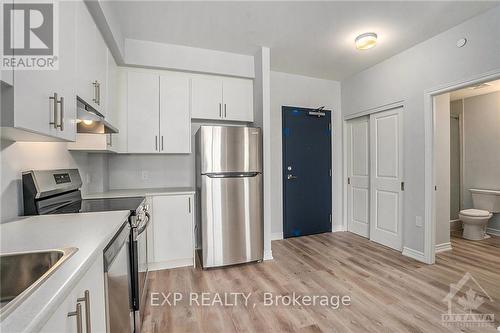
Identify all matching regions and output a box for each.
[370,107,404,250]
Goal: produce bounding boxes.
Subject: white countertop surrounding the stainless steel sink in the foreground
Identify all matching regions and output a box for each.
[0,211,130,332]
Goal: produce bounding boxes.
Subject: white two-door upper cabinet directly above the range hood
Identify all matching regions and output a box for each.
[76,1,107,114]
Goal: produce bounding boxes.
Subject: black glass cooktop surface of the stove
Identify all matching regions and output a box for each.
[51,197,144,214]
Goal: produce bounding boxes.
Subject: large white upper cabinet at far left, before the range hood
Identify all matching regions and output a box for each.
[2,1,76,141]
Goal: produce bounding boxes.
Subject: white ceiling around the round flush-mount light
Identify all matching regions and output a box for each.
[110,1,499,80]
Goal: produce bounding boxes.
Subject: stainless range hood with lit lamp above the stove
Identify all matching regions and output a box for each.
[76,96,118,134]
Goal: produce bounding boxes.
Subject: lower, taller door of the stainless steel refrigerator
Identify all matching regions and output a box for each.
[201,174,264,268]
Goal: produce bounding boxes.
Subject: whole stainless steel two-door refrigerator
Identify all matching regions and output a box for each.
[196,126,264,268]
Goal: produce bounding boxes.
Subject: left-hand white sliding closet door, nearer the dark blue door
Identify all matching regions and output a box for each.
[347,117,370,237]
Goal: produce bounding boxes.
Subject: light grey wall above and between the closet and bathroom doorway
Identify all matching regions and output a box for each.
[342,7,500,252]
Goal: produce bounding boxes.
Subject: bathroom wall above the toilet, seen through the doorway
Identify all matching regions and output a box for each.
[462,92,500,231]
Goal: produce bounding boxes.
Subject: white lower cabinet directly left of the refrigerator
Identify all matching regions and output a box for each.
[150,195,194,270]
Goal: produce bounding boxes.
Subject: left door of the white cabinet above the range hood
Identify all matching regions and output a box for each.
[76,1,97,108]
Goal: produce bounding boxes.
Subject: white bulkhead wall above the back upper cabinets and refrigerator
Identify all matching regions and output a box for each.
[124,38,255,78]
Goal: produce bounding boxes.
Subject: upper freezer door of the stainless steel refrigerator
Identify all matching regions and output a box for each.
[197,126,262,174]
